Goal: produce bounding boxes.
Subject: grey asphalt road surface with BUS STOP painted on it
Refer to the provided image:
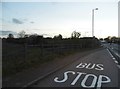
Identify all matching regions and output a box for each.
[30,48,120,89]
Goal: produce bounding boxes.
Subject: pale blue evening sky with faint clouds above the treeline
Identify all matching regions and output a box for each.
[0,0,119,38]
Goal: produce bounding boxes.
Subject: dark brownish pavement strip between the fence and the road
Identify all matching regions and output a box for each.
[2,48,102,89]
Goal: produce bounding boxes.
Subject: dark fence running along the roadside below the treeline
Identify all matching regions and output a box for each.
[2,39,99,75]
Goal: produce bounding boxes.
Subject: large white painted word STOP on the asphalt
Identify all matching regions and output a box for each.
[54,71,111,89]
